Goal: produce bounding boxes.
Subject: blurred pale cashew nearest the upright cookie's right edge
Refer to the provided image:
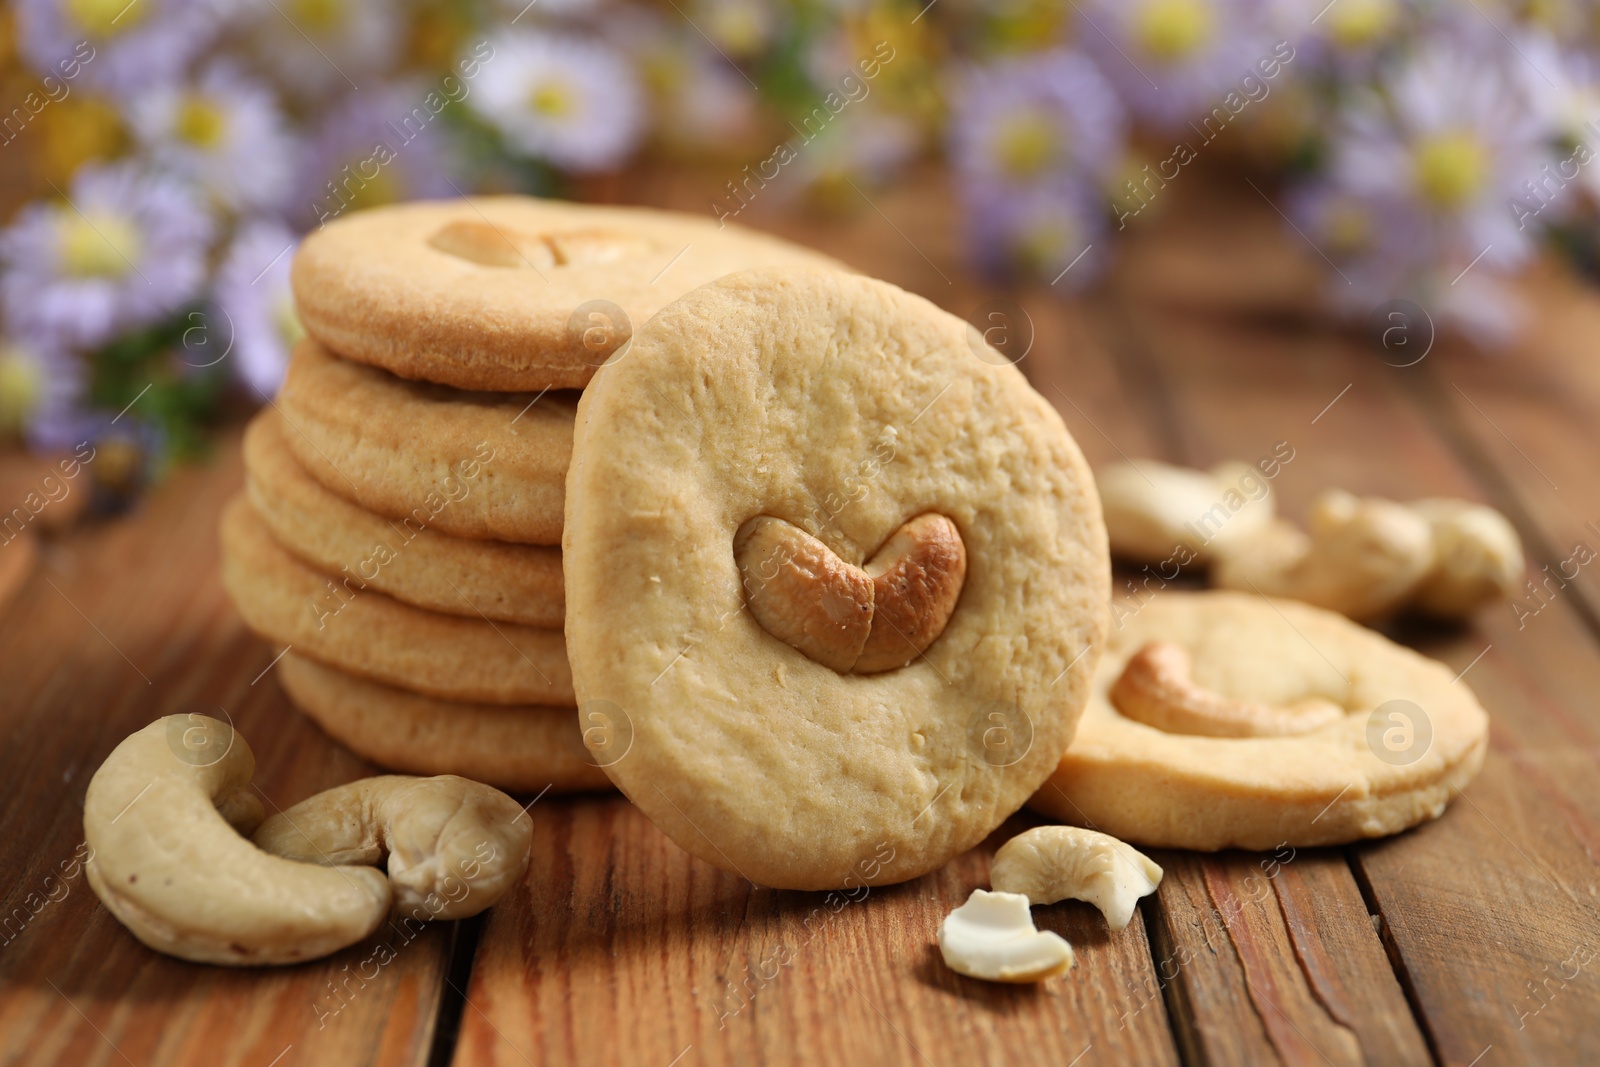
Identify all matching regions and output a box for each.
[1094,459,1272,563]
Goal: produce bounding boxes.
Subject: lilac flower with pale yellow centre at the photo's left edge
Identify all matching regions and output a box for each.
[0,163,213,347]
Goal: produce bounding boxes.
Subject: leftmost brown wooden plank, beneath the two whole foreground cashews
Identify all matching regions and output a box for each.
[0,435,451,1067]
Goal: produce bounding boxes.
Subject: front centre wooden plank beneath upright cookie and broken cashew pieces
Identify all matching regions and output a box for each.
[456,798,1178,1067]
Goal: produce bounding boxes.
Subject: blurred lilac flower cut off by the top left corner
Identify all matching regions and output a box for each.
[16,0,219,93]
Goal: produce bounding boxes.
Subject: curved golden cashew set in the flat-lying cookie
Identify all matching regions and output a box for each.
[1110,641,1344,737]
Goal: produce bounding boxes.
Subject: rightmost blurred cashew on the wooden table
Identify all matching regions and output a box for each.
[1411,498,1523,619]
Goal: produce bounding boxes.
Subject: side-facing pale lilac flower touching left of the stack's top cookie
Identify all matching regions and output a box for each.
[213,221,306,400]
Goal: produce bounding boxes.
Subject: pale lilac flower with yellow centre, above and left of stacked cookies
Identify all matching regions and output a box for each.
[128,62,294,211]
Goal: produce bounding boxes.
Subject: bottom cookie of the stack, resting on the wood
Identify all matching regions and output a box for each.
[278,653,611,793]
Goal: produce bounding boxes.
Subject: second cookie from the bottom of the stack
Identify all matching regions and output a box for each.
[222,494,573,704]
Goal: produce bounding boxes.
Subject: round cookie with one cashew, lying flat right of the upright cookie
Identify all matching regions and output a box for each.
[1030,592,1488,851]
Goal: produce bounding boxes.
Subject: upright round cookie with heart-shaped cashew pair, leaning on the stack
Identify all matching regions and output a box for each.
[563,270,1109,889]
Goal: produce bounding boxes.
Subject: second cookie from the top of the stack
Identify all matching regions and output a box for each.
[277,341,578,545]
